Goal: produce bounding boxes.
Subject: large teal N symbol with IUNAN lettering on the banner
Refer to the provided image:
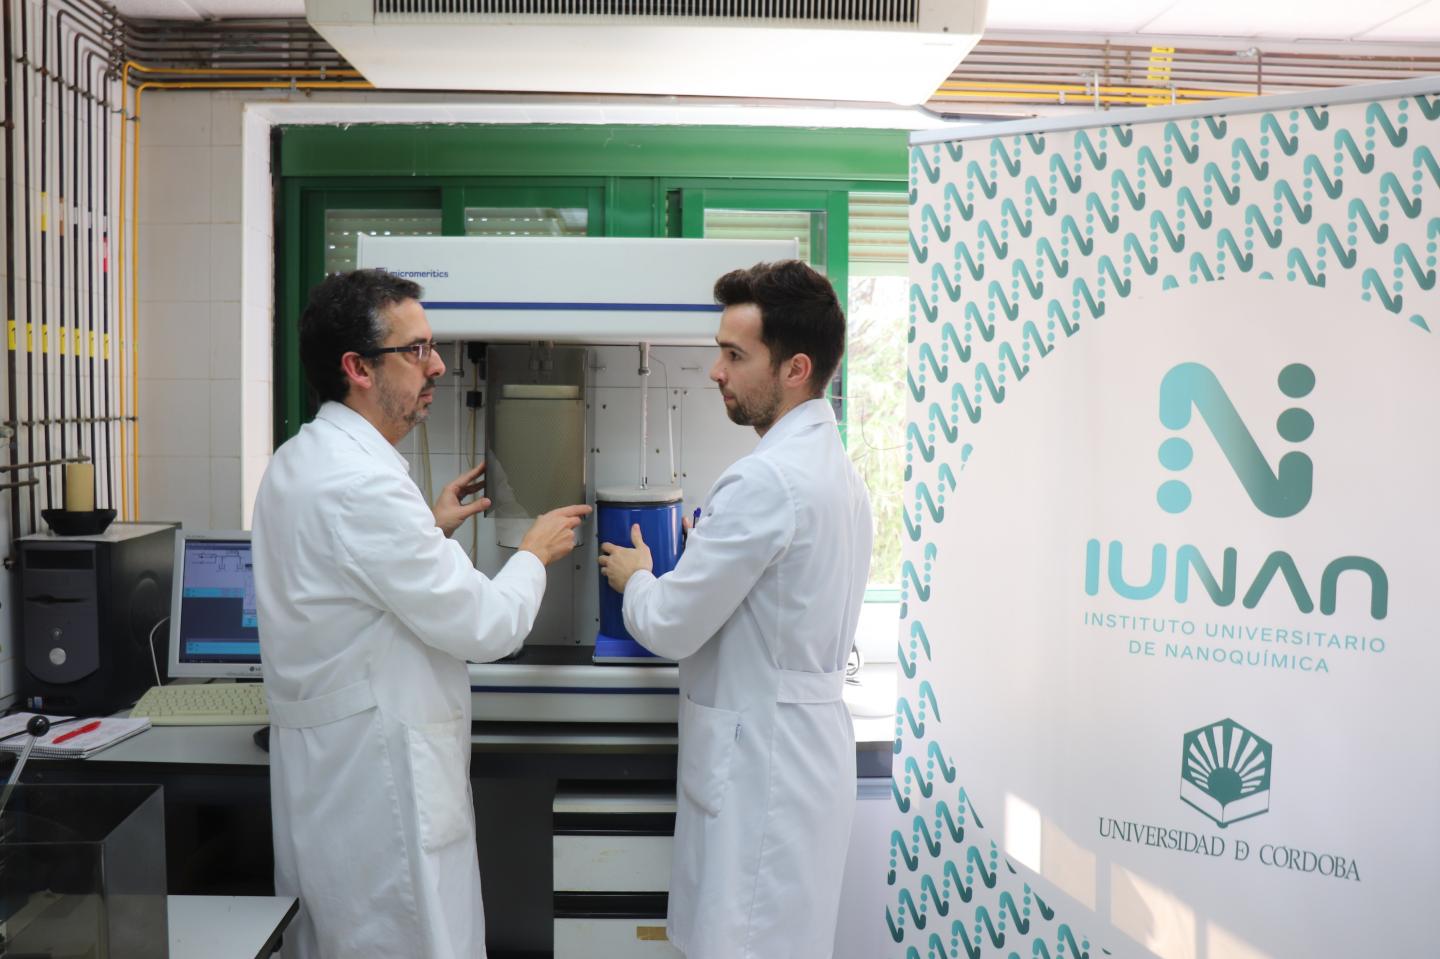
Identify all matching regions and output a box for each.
[1084,363,1390,619]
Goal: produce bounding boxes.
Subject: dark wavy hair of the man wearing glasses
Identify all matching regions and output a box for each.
[300,269,422,402]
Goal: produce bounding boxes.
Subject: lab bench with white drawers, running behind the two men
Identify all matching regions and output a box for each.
[26,648,896,959]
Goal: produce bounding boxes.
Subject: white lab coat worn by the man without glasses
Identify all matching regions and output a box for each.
[622,400,874,959]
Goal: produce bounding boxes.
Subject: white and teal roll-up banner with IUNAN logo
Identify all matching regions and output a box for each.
[886,78,1440,959]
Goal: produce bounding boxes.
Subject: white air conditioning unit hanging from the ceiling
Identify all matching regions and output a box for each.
[305,0,986,105]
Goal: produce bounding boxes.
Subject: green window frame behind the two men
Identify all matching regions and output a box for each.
[274,124,909,599]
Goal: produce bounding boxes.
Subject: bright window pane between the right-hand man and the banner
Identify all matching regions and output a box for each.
[845,193,910,589]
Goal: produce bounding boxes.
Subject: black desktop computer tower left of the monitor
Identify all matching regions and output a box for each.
[17,523,176,716]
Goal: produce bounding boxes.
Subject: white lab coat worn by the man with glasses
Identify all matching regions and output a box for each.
[253,403,546,959]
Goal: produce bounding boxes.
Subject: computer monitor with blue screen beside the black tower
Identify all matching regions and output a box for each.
[170,530,261,680]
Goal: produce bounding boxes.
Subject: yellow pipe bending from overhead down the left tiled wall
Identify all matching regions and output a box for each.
[115,67,374,518]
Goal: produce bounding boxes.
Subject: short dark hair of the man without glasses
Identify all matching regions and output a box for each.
[714,259,845,396]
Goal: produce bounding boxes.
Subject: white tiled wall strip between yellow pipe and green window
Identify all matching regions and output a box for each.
[138,92,274,528]
